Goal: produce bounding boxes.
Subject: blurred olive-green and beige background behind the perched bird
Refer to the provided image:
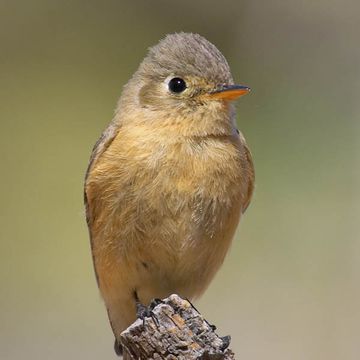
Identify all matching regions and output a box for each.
[0,0,360,360]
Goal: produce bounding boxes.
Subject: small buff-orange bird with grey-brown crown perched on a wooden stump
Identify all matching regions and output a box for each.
[85,33,254,354]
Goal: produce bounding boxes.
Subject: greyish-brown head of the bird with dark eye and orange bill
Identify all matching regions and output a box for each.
[116,33,250,133]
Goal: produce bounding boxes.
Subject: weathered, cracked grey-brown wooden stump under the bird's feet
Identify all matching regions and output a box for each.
[120,295,235,360]
